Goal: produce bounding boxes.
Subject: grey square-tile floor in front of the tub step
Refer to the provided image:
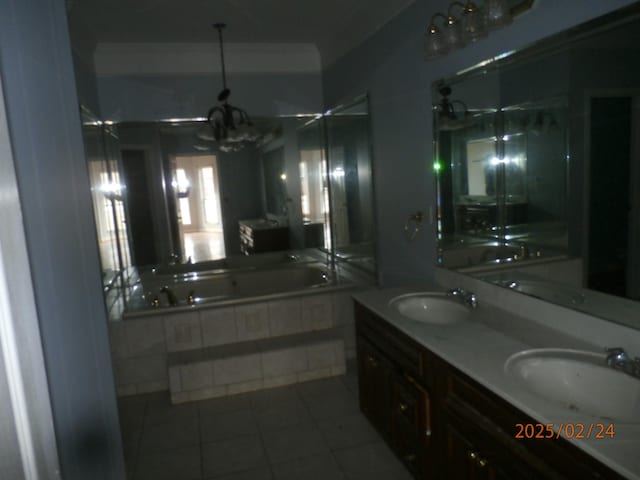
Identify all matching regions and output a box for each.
[119,363,411,480]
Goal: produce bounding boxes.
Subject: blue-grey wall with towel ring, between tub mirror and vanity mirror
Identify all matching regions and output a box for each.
[323,0,633,285]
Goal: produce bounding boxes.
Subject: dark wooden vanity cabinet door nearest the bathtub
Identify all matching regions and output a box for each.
[358,337,391,441]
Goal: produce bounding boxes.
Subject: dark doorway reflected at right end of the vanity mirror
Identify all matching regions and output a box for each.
[587,94,640,298]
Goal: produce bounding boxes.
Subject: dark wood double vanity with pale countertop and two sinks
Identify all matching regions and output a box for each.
[354,282,640,480]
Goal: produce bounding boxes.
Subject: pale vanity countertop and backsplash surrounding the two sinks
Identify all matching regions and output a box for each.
[354,284,640,480]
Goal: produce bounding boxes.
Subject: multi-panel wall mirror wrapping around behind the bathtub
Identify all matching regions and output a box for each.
[83,95,376,318]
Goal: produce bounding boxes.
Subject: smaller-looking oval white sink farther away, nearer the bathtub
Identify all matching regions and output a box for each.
[389,293,471,325]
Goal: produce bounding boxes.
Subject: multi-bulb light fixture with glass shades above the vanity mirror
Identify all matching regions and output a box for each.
[424,0,534,60]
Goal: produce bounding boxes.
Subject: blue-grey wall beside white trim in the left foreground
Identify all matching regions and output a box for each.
[0,0,124,480]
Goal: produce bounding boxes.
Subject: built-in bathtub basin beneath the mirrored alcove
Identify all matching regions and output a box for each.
[124,263,344,318]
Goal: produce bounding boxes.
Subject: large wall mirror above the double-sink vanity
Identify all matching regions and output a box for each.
[433,4,640,328]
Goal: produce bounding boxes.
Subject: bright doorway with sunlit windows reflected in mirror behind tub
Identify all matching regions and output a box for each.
[175,155,226,263]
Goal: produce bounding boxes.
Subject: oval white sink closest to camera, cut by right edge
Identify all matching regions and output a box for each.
[505,348,640,423]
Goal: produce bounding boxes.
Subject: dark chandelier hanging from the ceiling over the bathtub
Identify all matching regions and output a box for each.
[208,23,261,152]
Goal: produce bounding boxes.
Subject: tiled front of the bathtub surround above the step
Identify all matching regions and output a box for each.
[109,289,355,396]
